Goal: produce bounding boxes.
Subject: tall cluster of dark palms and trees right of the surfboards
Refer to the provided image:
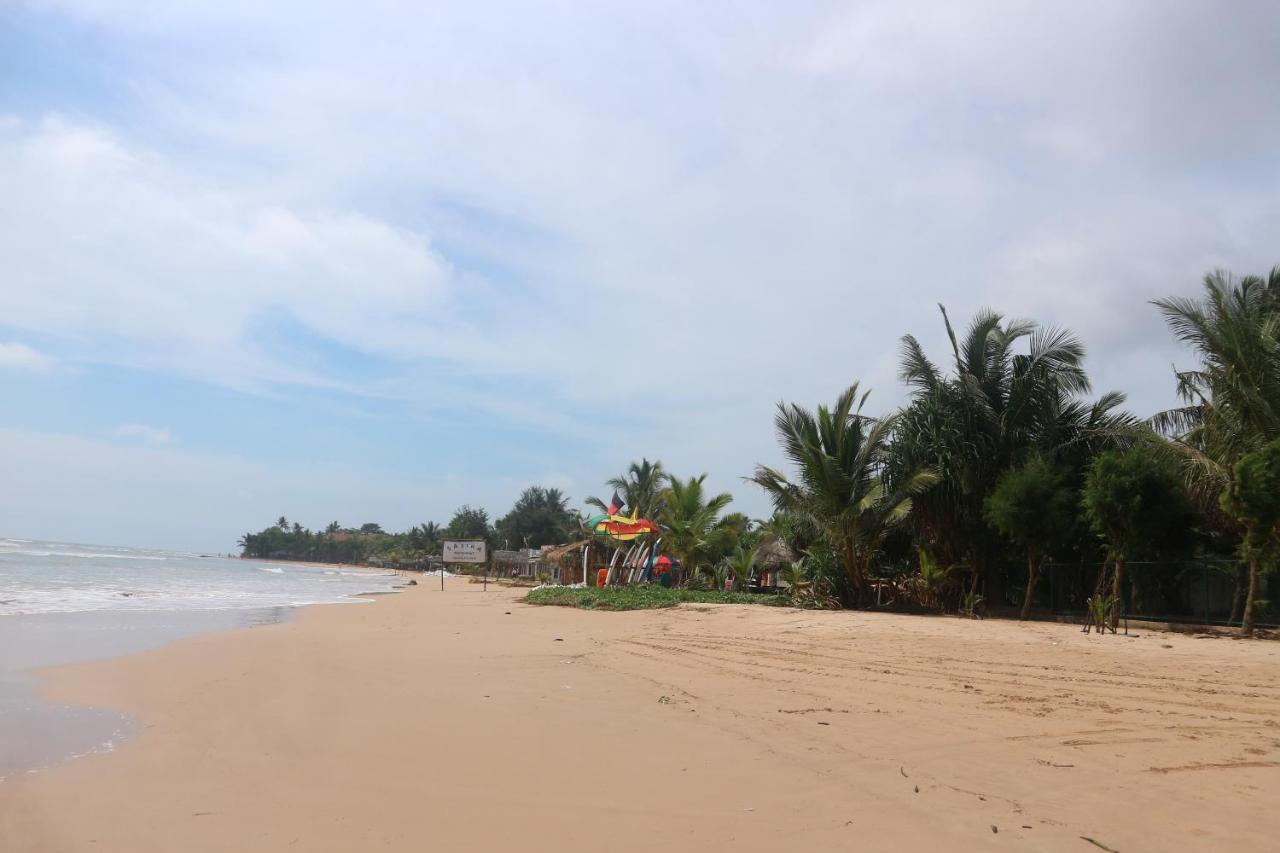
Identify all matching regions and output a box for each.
[750,268,1280,633]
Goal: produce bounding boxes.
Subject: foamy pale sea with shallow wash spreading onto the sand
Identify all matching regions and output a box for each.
[0,538,403,784]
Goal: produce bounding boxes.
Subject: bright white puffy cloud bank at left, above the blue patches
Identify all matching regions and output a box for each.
[0,117,451,383]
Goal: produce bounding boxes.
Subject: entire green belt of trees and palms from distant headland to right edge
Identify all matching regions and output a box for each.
[242,268,1280,633]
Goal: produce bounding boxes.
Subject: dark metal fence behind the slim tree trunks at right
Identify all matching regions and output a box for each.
[1034,560,1280,628]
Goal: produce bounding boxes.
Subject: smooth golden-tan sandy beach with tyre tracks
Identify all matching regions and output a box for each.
[0,579,1280,853]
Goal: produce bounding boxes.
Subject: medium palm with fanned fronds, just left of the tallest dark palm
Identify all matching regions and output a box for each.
[750,383,937,603]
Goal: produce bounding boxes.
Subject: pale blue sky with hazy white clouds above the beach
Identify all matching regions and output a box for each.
[0,0,1280,552]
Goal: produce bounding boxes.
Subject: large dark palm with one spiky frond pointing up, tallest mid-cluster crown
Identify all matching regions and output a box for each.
[890,305,1138,592]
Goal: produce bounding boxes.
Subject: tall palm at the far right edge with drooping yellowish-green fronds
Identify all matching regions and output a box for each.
[1151,266,1280,626]
